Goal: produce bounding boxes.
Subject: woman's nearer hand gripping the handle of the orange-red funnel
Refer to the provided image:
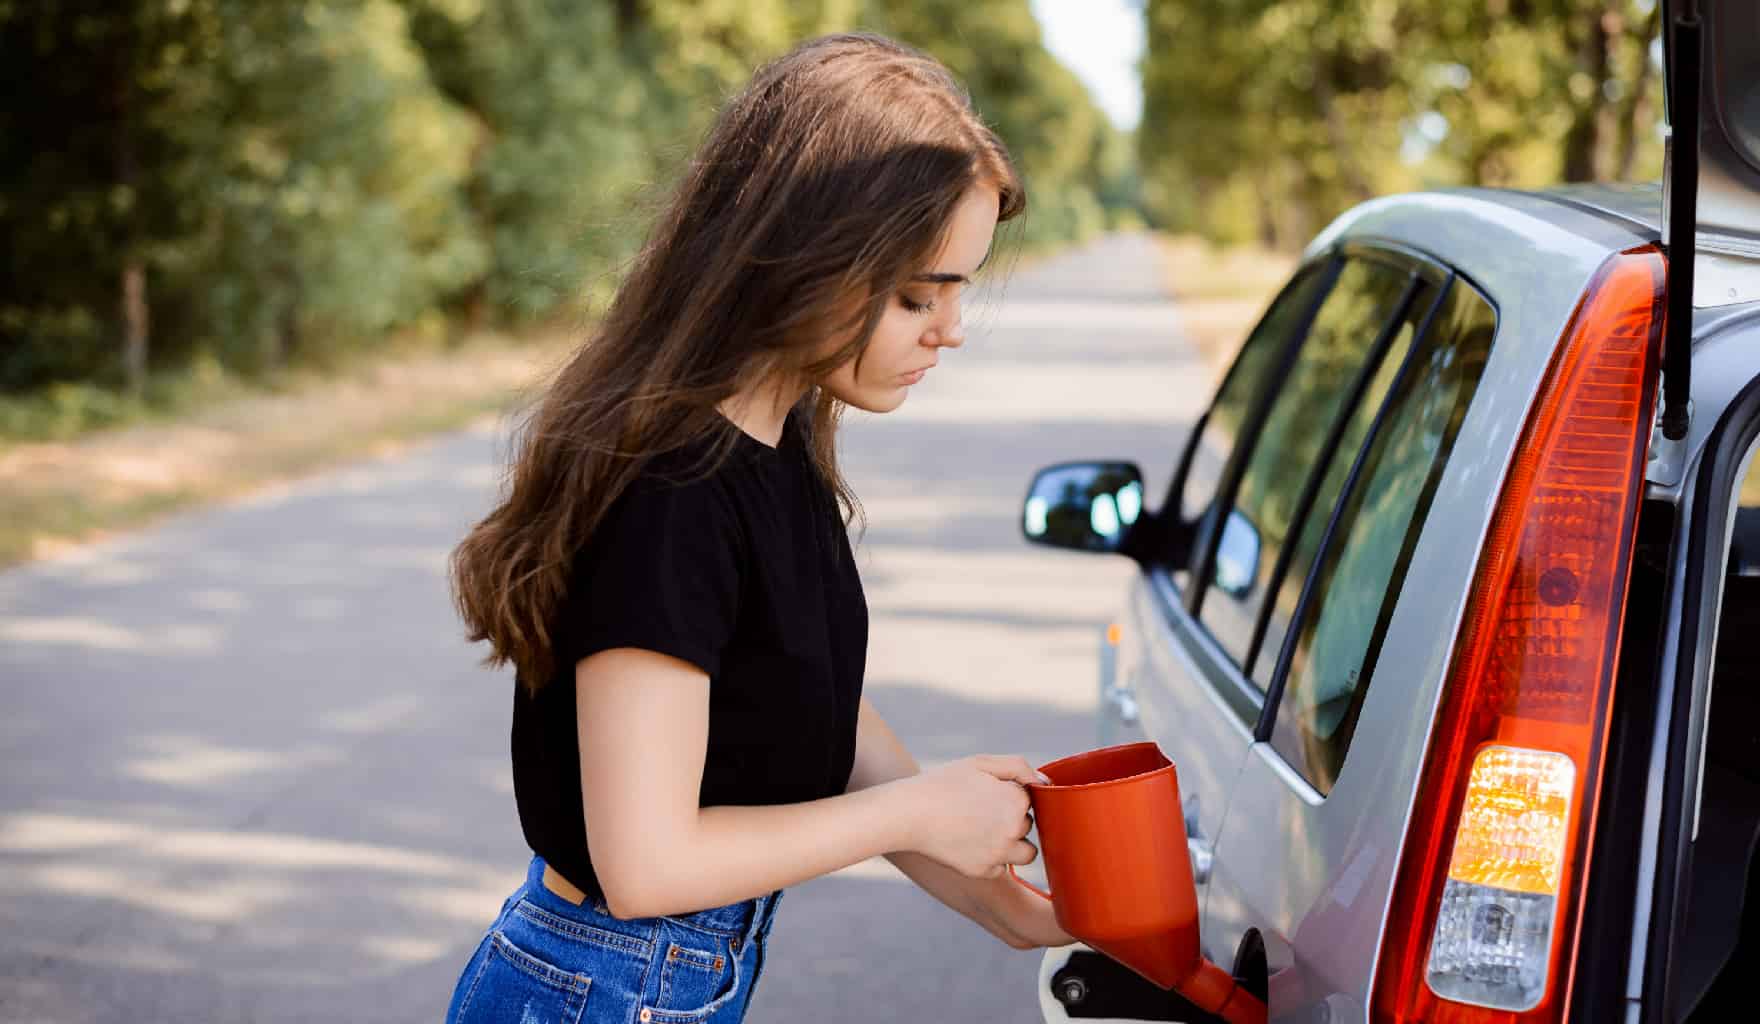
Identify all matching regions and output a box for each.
[898,755,1047,878]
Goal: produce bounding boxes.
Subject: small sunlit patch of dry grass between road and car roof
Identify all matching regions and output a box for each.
[1156,236,1295,371]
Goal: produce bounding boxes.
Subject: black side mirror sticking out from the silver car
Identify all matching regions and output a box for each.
[1021,463,1142,552]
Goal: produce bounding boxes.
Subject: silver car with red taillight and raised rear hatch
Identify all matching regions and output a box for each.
[1023,0,1760,1022]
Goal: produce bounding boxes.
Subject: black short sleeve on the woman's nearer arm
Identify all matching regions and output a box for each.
[563,479,744,677]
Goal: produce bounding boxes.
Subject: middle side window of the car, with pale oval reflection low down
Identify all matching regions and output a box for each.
[1199,259,1412,669]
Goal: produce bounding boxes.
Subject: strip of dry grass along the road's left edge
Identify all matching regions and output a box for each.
[0,336,570,565]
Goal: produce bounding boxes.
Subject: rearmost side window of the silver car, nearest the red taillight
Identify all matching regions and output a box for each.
[1262,282,1496,792]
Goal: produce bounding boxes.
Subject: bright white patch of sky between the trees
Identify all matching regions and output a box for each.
[1031,0,1142,128]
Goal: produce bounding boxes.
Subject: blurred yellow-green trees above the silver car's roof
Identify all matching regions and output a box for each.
[1139,0,1663,250]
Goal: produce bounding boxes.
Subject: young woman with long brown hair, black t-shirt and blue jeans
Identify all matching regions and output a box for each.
[449,35,1074,1024]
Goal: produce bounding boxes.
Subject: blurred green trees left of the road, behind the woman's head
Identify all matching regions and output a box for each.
[0,0,1133,415]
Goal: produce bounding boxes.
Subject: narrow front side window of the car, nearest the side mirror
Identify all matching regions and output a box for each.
[1179,266,1327,523]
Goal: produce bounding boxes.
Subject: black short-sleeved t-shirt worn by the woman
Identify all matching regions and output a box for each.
[512,413,868,897]
